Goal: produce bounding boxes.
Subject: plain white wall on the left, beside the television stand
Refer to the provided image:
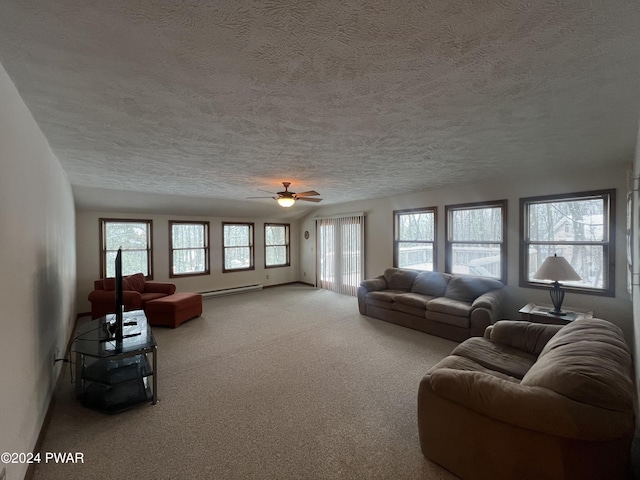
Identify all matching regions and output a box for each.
[0,65,76,479]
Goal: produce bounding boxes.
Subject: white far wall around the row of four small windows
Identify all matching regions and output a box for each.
[76,211,299,312]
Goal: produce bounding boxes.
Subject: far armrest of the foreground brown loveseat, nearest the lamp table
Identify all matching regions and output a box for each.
[488,320,562,356]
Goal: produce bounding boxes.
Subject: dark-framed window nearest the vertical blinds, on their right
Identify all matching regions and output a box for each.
[393,207,436,270]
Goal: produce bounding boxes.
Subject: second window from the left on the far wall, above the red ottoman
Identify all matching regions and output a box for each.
[169,221,209,277]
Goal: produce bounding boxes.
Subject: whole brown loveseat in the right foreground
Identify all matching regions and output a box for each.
[418,318,635,480]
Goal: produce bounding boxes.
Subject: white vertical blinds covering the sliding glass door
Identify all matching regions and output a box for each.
[316,213,364,296]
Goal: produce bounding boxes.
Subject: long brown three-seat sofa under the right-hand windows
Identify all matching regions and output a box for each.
[358,268,504,342]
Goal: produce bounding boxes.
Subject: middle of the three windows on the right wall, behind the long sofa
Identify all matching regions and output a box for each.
[445,200,507,283]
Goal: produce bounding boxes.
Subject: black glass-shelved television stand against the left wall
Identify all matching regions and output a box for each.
[71,310,158,413]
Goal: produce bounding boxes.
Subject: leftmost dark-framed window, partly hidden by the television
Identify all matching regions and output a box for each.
[100,218,153,280]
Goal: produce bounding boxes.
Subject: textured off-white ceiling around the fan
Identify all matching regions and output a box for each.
[0,0,640,215]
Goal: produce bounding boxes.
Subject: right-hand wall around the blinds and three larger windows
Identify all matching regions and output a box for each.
[299,164,633,342]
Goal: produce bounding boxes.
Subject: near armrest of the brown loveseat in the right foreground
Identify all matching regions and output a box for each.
[420,368,634,441]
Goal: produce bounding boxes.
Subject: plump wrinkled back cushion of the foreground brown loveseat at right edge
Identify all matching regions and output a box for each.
[522,318,634,412]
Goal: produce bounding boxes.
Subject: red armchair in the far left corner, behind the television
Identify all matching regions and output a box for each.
[89,273,176,318]
